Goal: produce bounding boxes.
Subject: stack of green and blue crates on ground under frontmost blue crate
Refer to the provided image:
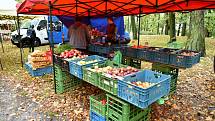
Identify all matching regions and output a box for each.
[90,94,151,121]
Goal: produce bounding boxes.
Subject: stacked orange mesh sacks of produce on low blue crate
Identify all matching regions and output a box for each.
[28,50,51,70]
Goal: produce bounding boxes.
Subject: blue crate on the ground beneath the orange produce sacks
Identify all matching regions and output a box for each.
[25,63,53,77]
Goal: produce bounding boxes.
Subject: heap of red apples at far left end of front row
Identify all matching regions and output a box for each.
[59,49,88,59]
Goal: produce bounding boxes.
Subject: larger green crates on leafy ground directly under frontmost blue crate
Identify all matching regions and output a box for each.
[106,94,151,121]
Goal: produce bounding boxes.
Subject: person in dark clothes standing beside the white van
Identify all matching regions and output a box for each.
[27,25,36,52]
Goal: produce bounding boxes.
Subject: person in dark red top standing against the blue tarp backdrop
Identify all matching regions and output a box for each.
[107,17,117,43]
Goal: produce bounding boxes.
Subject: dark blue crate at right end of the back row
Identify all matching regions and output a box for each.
[170,50,201,68]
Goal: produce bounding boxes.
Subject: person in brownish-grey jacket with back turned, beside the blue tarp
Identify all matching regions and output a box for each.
[68,17,90,51]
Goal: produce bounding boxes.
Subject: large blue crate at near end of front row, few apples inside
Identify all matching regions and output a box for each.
[118,70,171,108]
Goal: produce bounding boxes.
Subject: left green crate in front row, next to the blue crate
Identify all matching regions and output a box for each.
[83,67,100,86]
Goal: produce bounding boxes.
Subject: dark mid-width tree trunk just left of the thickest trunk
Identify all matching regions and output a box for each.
[169,13,176,43]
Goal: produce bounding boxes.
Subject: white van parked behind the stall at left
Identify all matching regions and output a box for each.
[11,16,49,47]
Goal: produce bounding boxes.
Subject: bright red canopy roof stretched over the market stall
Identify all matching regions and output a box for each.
[17,0,215,17]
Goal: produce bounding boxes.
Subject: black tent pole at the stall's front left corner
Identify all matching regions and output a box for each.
[49,1,57,93]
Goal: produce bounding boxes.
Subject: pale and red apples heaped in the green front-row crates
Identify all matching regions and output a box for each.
[91,66,139,77]
